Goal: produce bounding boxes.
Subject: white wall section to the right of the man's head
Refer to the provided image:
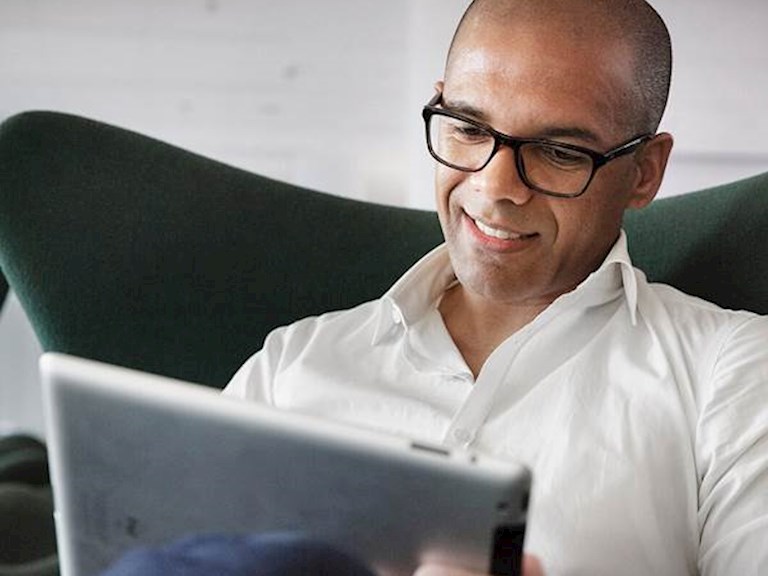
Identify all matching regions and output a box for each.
[654,0,768,195]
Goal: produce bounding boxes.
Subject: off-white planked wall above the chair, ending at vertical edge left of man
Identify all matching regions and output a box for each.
[0,0,414,202]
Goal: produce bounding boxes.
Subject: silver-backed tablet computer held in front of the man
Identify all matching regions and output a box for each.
[40,353,530,576]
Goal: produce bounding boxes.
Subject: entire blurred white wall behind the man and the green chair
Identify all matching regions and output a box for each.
[0,0,768,434]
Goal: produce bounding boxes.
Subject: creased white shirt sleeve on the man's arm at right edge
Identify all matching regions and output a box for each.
[696,317,768,576]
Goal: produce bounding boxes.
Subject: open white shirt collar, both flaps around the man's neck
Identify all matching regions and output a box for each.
[372,230,637,346]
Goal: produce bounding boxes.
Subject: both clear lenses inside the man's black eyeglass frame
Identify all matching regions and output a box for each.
[429,114,593,195]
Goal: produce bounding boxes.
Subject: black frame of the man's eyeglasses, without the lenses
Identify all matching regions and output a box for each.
[421,92,655,198]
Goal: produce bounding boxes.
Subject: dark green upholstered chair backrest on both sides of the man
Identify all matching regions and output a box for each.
[0,112,768,386]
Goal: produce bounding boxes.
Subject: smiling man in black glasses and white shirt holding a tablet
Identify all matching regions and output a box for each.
[226,0,768,575]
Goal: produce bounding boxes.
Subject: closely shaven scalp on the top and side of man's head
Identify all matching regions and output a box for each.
[446,0,672,133]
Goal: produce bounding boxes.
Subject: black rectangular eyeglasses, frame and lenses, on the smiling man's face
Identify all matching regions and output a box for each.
[422,92,653,198]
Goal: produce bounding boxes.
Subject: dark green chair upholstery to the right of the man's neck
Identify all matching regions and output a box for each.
[625,172,768,314]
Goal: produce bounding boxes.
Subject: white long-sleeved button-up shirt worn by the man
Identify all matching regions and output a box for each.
[225,234,768,576]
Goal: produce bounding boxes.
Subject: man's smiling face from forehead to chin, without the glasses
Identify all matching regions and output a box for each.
[436,19,650,306]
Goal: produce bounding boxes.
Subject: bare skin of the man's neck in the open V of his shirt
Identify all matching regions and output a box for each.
[439,284,547,378]
